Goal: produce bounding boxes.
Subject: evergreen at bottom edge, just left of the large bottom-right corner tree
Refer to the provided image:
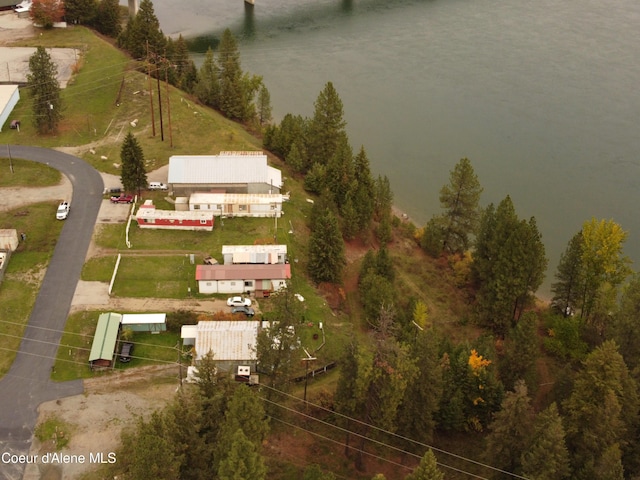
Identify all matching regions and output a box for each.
[521,403,570,480]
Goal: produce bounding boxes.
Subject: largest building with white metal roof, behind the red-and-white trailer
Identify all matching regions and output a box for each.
[167,152,282,195]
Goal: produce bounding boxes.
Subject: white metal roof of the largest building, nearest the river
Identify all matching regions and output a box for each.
[168,152,282,188]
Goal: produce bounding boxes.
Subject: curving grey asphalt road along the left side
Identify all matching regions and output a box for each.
[0,145,104,480]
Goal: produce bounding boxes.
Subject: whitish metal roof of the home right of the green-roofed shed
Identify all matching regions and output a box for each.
[196,321,260,361]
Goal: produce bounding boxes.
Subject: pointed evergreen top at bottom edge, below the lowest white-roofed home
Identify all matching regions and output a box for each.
[218,429,267,480]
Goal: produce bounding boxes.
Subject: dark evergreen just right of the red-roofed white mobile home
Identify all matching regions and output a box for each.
[307,204,346,283]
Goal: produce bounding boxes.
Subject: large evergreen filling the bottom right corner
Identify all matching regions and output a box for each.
[564,341,639,480]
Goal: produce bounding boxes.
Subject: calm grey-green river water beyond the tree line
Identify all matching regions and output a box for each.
[149,0,640,296]
